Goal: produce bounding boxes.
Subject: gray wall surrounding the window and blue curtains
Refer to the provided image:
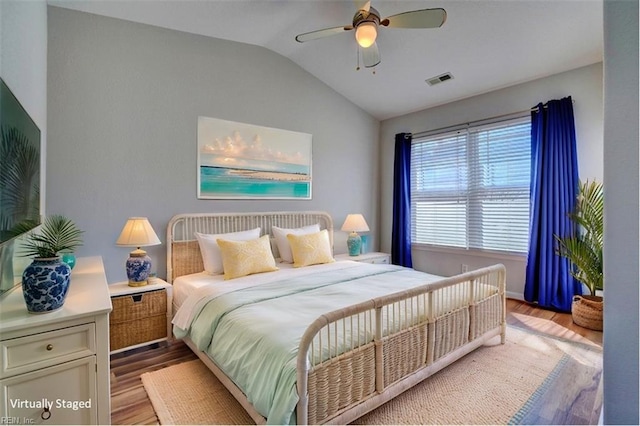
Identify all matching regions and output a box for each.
[380,63,603,299]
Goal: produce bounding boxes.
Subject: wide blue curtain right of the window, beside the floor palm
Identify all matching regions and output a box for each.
[524,97,582,312]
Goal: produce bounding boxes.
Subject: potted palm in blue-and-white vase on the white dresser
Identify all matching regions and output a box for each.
[15,215,83,313]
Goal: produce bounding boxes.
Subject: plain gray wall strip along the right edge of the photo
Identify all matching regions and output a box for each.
[603,0,640,425]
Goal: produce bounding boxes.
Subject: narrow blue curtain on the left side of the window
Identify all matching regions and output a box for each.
[391,133,413,268]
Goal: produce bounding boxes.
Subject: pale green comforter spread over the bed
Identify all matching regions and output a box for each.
[174,263,441,424]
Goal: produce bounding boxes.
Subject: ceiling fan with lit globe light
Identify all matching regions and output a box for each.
[296,1,447,68]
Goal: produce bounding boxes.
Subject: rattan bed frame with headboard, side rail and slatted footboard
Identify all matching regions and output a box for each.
[167,212,506,424]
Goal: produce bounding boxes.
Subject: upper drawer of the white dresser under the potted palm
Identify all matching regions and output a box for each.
[0,323,96,378]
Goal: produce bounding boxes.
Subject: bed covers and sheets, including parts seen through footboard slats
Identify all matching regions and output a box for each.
[172,261,497,424]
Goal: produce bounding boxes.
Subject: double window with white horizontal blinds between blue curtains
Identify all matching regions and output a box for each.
[411,117,531,253]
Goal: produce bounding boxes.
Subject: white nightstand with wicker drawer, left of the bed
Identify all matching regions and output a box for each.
[109,278,172,354]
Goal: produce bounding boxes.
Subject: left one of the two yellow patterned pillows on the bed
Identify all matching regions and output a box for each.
[218,235,278,280]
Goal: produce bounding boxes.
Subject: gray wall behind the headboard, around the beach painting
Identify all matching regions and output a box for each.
[47,7,379,282]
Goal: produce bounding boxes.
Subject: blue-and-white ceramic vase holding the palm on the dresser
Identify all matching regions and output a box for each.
[22,257,71,314]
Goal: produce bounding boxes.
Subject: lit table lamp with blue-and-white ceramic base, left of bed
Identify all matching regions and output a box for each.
[116,217,161,287]
